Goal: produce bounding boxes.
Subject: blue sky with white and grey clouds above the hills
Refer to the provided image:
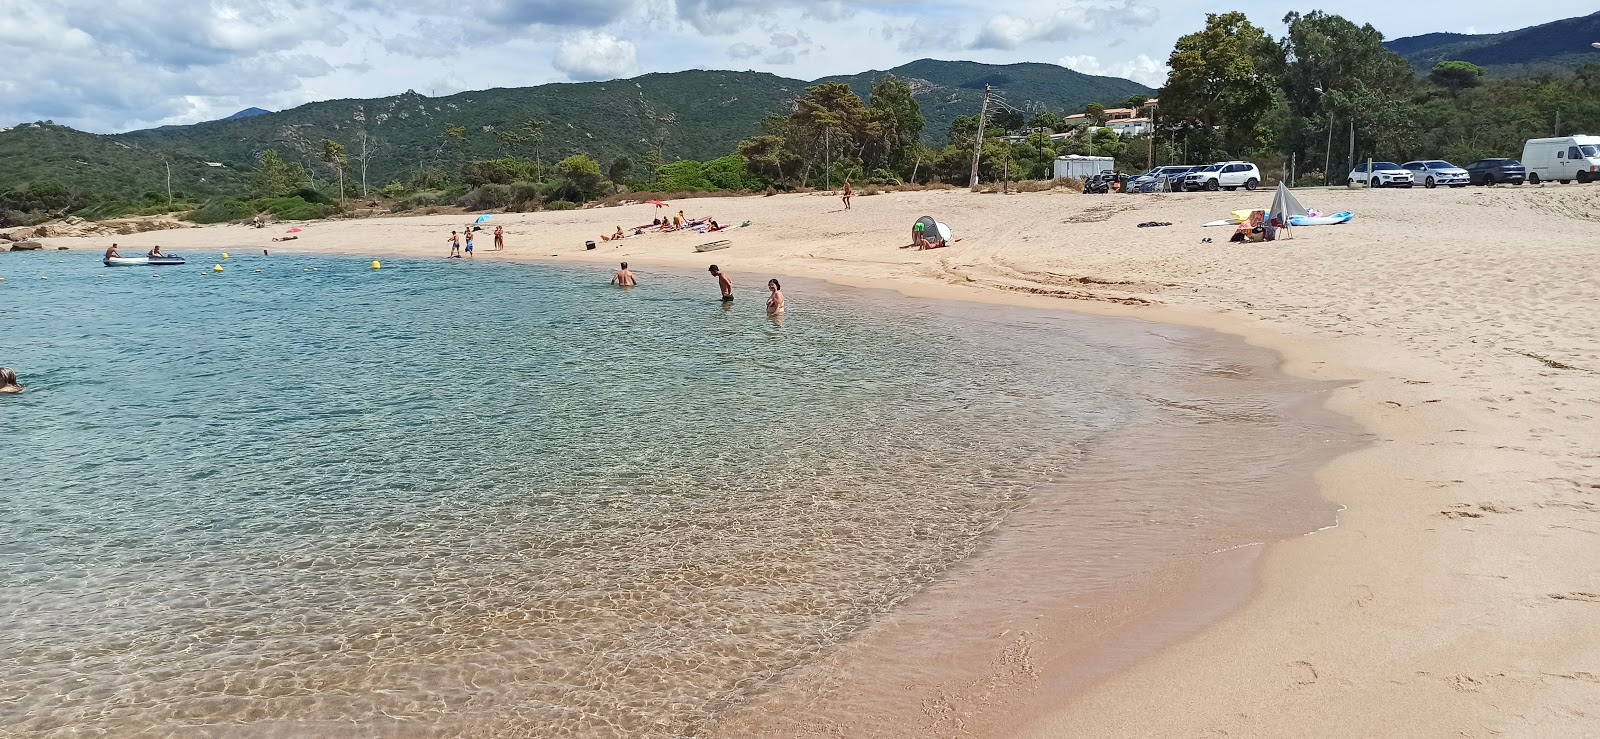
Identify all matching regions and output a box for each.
[0,0,1594,133]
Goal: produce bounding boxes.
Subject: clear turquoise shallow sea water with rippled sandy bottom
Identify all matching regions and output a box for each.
[0,253,1141,737]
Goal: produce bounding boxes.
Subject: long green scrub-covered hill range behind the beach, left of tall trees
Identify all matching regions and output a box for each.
[0,59,1150,211]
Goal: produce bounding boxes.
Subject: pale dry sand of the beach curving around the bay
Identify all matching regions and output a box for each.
[28,186,1600,737]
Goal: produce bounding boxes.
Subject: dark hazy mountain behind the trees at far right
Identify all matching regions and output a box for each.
[1384,13,1600,77]
